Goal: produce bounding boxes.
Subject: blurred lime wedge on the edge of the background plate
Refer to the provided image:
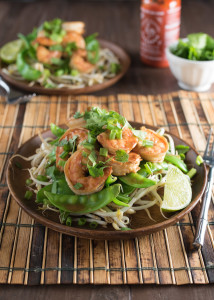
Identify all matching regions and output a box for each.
[0,40,23,64]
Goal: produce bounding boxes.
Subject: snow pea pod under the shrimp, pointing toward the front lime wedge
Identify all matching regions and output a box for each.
[119,173,156,188]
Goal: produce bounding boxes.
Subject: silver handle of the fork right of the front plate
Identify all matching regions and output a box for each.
[193,167,214,247]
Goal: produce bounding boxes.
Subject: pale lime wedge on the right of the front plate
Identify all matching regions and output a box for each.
[161,166,192,212]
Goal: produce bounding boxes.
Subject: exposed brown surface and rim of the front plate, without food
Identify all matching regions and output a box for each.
[7,122,207,240]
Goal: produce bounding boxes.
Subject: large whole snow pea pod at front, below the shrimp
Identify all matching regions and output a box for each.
[44,184,120,214]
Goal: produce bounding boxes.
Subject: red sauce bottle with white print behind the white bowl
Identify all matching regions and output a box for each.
[140,0,181,68]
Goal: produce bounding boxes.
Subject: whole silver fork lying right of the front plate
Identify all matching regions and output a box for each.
[193,129,214,247]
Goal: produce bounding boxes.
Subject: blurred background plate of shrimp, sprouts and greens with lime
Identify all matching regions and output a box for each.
[0,19,130,95]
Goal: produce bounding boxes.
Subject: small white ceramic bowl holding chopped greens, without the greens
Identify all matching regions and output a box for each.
[166,39,214,92]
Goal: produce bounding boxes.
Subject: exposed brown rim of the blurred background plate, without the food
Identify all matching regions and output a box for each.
[0,39,130,95]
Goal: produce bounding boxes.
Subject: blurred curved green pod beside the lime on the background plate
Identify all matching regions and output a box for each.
[16,50,42,81]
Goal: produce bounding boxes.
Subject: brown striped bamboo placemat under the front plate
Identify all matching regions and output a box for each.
[0,91,214,285]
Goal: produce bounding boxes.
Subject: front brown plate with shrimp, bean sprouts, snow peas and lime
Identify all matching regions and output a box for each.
[7,108,206,239]
